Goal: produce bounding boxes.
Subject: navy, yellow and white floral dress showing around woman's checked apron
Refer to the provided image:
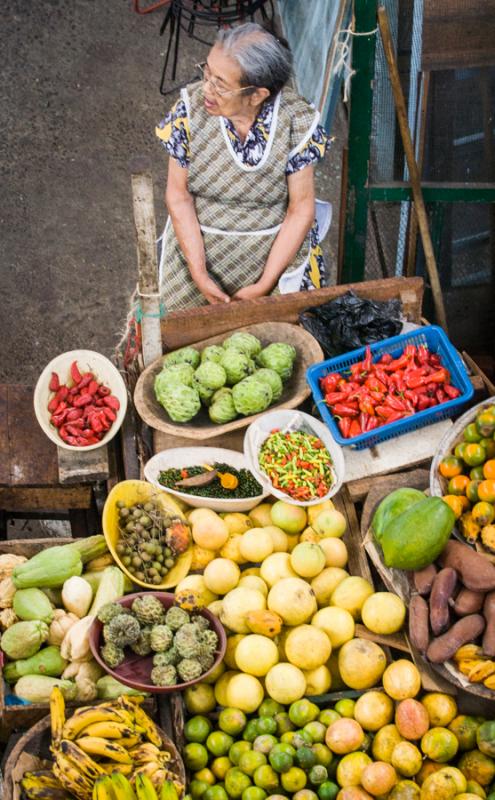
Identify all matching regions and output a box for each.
[155,100,330,291]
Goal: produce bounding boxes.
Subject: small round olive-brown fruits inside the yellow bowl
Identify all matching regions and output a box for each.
[115,499,191,586]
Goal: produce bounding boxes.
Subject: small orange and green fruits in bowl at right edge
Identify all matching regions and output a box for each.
[439,405,495,550]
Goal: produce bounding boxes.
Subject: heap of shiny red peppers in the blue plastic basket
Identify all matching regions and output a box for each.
[320,344,461,439]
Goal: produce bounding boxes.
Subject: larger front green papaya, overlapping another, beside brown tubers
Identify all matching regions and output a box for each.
[380,497,455,570]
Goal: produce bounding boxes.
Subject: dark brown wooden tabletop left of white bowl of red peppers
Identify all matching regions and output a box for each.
[7,384,58,486]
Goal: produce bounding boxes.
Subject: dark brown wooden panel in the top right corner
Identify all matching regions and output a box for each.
[421,0,495,70]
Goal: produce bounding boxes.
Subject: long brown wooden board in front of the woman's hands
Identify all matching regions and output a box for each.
[161,278,423,351]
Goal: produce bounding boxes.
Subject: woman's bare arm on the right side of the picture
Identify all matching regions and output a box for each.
[233,166,315,300]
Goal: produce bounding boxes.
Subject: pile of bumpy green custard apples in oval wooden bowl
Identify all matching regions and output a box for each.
[154,331,297,425]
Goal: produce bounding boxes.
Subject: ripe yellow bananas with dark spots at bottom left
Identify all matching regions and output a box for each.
[22,688,184,800]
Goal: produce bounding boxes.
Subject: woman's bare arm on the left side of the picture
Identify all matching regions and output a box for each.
[165,158,230,304]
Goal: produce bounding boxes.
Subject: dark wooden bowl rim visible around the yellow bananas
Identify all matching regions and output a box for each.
[3,712,186,800]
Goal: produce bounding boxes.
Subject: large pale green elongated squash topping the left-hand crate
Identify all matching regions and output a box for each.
[12,537,84,589]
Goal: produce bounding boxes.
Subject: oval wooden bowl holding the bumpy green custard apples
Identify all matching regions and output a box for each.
[134,322,323,439]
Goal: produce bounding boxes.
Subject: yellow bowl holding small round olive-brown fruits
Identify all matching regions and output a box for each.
[102,480,192,591]
